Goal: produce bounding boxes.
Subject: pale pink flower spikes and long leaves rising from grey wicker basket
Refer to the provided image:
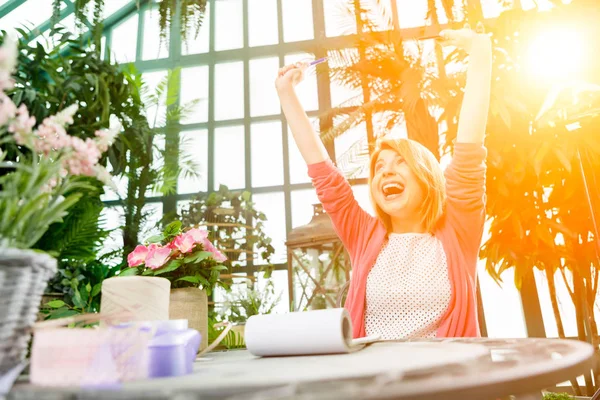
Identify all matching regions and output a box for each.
[0,36,121,248]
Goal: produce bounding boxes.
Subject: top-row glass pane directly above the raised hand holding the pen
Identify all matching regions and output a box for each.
[281,0,314,42]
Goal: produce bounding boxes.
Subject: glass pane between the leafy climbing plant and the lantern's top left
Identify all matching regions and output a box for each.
[252,192,287,264]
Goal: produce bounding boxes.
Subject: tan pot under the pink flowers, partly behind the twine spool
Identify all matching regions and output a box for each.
[169,288,208,350]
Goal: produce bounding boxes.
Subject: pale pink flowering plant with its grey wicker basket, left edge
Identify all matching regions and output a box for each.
[0,37,120,374]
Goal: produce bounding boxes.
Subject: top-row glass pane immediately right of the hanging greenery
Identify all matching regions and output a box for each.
[215,0,244,51]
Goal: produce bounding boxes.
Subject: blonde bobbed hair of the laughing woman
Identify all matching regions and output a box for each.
[369,138,446,232]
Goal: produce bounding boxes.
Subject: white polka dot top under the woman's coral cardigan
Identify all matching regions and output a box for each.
[365,233,452,340]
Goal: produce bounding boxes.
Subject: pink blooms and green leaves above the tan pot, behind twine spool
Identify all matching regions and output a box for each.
[120,221,227,294]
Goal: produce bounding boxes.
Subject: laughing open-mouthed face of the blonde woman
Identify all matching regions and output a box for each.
[371,149,425,219]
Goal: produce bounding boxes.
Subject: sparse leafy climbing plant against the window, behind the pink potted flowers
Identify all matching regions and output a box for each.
[181,185,275,277]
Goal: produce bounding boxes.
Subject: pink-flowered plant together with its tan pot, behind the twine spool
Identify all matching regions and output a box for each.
[119,221,227,350]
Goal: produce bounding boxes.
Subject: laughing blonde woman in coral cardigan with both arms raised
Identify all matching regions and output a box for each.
[275,23,492,340]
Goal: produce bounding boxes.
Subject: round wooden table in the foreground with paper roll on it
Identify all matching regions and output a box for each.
[8,338,594,400]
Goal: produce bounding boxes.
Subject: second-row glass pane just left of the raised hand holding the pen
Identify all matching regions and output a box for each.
[250,57,280,117]
